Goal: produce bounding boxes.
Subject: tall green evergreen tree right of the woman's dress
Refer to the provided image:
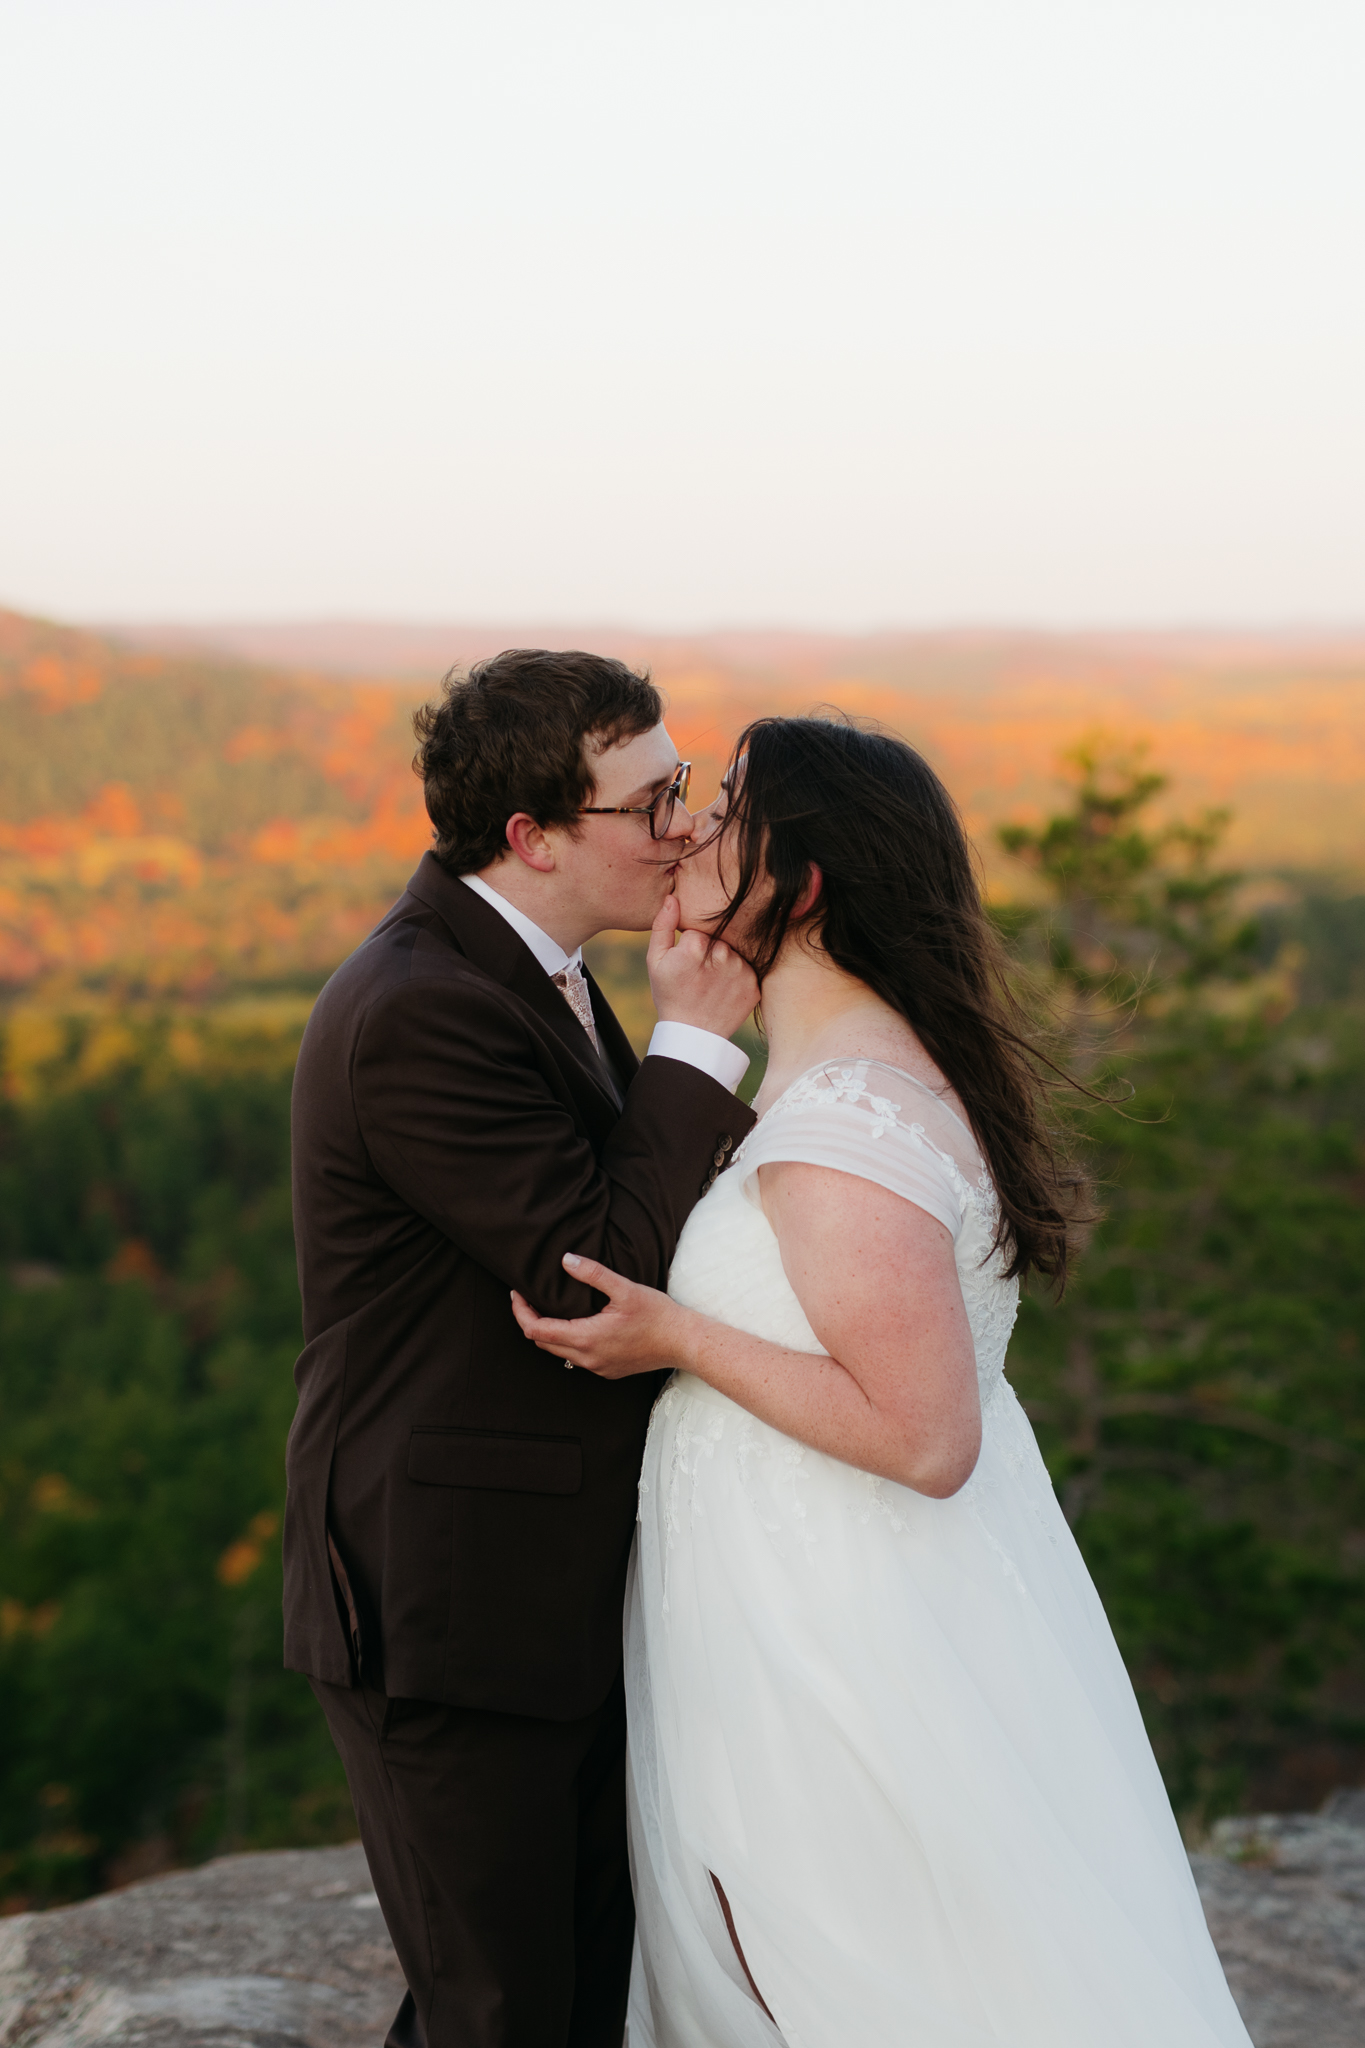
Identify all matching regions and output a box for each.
[1001,743,1365,1823]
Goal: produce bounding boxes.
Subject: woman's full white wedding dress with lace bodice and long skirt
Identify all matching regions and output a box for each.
[626,1061,1250,2048]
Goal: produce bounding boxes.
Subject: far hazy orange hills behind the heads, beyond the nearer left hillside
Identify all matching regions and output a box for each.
[121,618,1365,872]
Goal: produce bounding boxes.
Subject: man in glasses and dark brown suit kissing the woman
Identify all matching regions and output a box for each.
[284,651,757,2048]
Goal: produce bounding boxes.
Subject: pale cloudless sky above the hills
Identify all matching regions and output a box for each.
[0,0,1365,629]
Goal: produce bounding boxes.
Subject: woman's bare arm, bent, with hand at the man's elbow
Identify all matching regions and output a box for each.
[514,1161,980,1499]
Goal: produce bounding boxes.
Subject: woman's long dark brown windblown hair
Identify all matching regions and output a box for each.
[714,715,1083,1290]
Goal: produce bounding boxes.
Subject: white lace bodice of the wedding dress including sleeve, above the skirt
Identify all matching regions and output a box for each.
[669,1059,1019,1411]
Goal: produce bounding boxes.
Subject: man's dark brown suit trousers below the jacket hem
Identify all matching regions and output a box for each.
[313,1677,634,2048]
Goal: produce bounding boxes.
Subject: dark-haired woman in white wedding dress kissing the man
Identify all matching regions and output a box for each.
[516,719,1248,2048]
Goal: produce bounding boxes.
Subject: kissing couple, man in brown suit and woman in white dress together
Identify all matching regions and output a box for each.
[284,651,1248,2048]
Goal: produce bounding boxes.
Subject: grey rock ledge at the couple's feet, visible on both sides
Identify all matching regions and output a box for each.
[0,1792,1365,2048]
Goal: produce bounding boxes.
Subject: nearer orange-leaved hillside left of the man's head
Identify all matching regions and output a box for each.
[0,612,428,995]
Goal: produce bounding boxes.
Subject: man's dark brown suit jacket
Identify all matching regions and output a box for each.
[284,854,753,1720]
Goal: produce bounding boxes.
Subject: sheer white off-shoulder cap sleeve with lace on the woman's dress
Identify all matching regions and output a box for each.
[731,1059,990,1241]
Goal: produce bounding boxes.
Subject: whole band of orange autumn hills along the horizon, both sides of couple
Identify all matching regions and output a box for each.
[0,612,1365,997]
